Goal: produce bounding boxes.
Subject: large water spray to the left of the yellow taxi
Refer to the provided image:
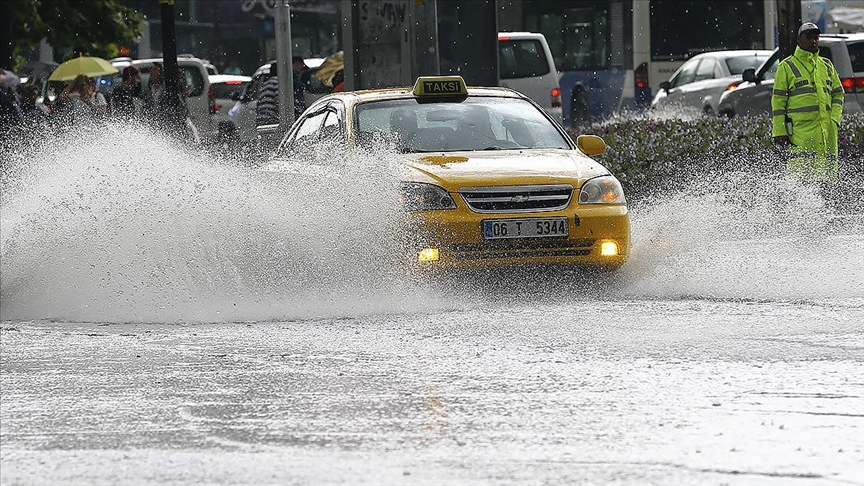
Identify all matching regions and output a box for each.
[0,126,446,322]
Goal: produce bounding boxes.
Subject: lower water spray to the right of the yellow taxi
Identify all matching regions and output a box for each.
[622,172,864,301]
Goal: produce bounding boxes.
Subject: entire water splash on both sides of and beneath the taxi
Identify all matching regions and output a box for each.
[0,126,864,322]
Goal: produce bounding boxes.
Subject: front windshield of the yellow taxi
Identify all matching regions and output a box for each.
[356,97,570,152]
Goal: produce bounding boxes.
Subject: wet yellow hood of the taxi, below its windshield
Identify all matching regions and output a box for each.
[404,149,609,192]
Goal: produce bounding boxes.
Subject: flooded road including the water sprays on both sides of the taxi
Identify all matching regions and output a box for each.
[0,127,864,485]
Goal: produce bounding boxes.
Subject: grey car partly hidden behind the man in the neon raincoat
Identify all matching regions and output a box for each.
[718,33,864,118]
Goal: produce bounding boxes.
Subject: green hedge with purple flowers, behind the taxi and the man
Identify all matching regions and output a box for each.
[570,114,864,197]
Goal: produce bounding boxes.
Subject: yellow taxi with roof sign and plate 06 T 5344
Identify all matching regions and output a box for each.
[277,76,630,269]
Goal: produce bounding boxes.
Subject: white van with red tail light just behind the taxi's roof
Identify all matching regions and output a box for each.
[498,32,562,123]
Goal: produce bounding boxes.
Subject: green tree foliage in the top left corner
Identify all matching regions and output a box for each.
[7,0,144,68]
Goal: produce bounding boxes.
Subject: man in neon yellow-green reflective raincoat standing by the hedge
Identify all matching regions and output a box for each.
[771,22,844,182]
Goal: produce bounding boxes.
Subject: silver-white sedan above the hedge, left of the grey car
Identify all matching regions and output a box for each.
[651,50,771,115]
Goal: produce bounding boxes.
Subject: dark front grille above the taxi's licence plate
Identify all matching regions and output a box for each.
[459,184,573,213]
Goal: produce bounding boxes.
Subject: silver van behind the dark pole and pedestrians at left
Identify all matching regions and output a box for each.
[111,57,218,142]
